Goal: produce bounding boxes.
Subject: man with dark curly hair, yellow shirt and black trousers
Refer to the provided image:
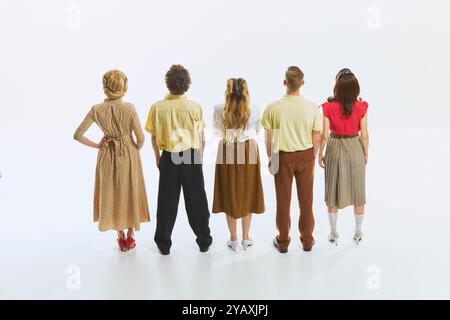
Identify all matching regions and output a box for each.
[145,65,212,255]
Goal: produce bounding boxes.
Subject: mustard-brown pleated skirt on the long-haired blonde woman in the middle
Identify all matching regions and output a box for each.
[212,140,265,219]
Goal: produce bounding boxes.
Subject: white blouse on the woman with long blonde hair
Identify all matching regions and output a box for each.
[213,103,261,142]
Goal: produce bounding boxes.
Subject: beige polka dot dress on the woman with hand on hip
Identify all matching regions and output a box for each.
[74,99,150,231]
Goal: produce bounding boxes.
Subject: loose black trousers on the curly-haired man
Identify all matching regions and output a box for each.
[155,149,212,251]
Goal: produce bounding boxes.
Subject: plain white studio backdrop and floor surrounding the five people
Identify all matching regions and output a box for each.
[0,0,450,299]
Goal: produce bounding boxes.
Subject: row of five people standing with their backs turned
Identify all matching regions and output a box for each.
[74,65,368,255]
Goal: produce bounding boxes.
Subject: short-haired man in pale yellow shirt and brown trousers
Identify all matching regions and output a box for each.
[261,67,322,253]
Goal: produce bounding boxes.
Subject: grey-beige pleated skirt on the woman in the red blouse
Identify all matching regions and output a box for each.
[325,134,366,209]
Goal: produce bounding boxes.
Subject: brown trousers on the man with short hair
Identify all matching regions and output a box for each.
[275,148,315,249]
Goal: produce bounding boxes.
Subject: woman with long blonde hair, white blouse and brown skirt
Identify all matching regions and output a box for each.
[212,78,265,251]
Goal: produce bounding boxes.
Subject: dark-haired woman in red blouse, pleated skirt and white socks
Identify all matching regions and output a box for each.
[318,69,369,244]
